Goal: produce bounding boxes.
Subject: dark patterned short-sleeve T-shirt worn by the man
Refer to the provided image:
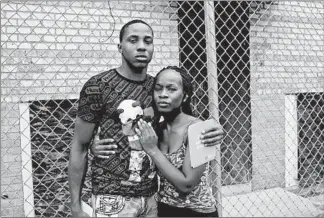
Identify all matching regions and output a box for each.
[77,69,157,196]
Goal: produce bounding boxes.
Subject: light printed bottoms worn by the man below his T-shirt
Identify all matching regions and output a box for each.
[92,195,157,217]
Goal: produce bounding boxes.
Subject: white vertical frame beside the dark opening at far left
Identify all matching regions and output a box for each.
[19,103,35,217]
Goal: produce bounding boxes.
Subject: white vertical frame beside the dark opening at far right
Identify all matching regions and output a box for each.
[285,95,298,187]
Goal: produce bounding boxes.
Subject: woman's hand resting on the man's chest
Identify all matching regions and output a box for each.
[135,119,159,155]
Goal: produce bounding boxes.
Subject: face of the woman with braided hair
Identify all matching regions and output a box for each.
[154,69,184,113]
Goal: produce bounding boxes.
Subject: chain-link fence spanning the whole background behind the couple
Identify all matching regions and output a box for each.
[1,1,324,217]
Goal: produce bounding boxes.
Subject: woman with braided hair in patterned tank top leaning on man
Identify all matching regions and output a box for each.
[136,66,218,217]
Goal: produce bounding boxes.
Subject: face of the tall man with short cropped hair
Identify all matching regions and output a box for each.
[119,23,154,68]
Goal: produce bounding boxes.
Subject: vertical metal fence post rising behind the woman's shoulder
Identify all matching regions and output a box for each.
[204,1,222,217]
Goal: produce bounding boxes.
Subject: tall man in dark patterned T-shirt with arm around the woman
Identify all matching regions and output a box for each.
[69,20,223,217]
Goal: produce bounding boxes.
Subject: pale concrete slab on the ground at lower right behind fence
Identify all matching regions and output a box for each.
[222,188,324,217]
